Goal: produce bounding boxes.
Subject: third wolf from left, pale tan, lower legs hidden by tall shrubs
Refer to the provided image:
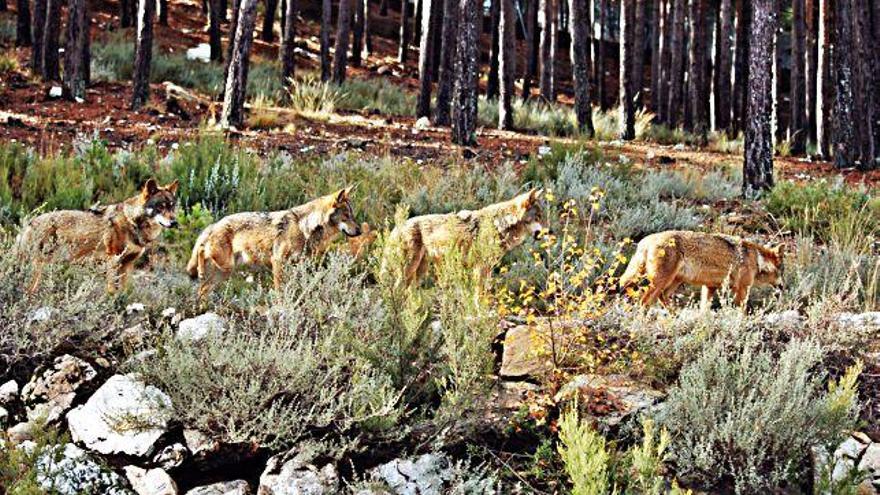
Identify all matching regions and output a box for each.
[384,189,544,285]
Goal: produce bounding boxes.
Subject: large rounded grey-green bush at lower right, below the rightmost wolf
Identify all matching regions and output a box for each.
[661,334,858,493]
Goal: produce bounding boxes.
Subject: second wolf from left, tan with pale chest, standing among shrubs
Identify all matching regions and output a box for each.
[186,187,361,297]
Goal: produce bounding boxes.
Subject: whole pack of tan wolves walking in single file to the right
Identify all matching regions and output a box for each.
[16,175,784,306]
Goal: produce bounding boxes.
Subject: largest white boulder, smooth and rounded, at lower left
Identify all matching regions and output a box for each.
[67,375,171,457]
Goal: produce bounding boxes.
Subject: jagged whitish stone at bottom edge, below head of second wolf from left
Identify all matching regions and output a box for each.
[257,454,339,495]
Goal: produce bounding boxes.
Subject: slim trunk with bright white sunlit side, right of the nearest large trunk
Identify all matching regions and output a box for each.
[816,0,834,158]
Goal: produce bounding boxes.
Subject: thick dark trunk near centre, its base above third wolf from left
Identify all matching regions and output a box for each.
[452,0,482,146]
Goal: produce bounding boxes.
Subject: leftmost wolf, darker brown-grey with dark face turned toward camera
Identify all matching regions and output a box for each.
[16,179,178,292]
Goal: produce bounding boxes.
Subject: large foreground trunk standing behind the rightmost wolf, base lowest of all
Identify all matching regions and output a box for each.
[743,0,778,197]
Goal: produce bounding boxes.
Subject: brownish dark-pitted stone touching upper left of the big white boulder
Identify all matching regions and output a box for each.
[21,354,98,423]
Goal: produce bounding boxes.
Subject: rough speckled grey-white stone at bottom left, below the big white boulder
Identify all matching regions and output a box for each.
[30,442,131,495]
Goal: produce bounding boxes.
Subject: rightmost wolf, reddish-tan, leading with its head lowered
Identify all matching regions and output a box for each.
[619,230,785,308]
